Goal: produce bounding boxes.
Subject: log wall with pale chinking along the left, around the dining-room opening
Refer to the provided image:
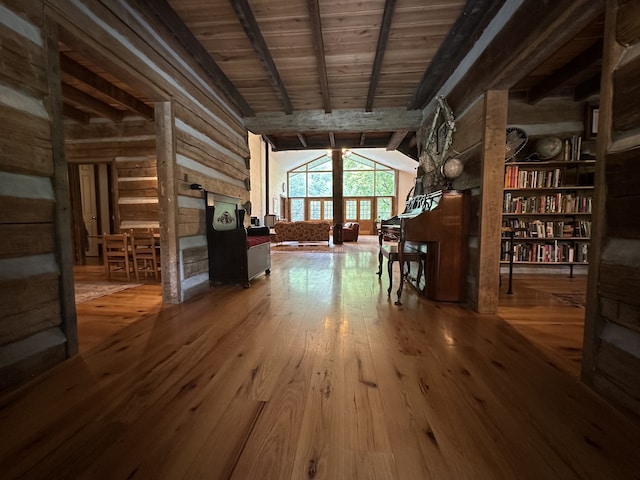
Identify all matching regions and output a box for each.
[0,0,249,389]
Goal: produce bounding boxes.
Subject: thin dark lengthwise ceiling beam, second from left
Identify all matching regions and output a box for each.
[229,0,293,115]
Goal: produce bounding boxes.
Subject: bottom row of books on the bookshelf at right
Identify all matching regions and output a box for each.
[502,240,589,263]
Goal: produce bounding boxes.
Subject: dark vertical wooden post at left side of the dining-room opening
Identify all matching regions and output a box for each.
[43,17,78,357]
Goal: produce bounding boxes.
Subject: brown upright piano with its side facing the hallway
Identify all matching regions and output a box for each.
[379,190,470,303]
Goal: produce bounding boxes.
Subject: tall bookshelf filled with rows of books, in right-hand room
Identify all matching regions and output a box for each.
[501,159,595,275]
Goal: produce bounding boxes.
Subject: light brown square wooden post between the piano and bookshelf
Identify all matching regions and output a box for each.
[476,90,509,313]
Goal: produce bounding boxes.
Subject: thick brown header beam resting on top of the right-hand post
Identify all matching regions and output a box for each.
[447,0,604,112]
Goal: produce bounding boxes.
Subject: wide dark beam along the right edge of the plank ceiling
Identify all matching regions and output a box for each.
[407,0,505,110]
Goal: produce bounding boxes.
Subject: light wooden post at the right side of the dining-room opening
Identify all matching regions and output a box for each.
[154,101,182,303]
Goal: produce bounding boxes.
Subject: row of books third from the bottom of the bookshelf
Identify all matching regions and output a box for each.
[503,192,593,213]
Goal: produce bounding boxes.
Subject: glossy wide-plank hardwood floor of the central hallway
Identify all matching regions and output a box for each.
[0,240,640,480]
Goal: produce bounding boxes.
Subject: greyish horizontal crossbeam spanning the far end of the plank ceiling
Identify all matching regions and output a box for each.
[244,108,422,135]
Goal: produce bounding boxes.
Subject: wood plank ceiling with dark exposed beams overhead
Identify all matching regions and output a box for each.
[61,0,603,158]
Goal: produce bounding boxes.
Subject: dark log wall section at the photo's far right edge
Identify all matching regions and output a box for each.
[582,0,640,418]
